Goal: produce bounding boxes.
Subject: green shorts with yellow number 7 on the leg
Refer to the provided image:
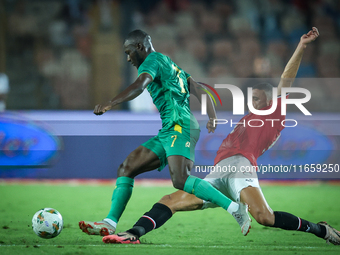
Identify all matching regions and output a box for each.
[142,125,201,171]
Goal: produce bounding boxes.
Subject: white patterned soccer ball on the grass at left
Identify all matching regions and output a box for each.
[32,208,63,239]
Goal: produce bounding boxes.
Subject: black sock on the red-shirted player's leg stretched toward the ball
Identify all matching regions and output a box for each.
[127,203,172,237]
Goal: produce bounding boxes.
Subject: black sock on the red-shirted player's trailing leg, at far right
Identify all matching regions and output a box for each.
[273,212,326,238]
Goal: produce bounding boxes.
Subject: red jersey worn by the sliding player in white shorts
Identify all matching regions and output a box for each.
[214,97,286,166]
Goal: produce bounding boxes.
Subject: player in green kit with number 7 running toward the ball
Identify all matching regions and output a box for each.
[79,30,251,239]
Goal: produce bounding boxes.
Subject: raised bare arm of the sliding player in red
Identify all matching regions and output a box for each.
[277,27,319,95]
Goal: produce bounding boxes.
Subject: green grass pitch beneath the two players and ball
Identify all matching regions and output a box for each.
[0,180,340,255]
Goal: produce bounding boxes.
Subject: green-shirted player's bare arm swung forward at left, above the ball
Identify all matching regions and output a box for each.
[93,73,152,115]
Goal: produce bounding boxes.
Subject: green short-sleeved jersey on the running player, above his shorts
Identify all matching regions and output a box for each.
[138,52,199,129]
